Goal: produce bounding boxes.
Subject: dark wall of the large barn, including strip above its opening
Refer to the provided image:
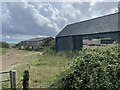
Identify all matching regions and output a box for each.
[56,32,120,51]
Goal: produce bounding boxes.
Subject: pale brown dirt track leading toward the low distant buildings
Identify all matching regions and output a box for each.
[2,49,42,71]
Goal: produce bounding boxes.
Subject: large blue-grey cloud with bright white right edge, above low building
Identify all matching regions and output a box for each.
[2,2,59,36]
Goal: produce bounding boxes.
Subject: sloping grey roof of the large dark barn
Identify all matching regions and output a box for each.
[56,13,120,37]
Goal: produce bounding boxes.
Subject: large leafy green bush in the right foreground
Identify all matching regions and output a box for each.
[52,45,120,90]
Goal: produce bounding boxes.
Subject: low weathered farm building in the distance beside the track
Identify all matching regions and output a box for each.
[19,37,54,49]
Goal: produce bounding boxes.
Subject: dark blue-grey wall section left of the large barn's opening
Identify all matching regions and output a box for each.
[56,36,83,51]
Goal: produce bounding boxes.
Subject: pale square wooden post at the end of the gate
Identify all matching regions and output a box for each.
[10,70,16,90]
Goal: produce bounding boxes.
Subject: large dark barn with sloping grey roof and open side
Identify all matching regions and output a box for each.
[56,12,120,51]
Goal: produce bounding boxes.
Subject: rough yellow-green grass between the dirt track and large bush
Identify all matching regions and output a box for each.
[15,54,70,88]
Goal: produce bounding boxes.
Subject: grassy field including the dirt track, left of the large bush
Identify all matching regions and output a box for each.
[2,49,72,88]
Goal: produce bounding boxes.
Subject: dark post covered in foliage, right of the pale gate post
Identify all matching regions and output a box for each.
[23,70,29,90]
